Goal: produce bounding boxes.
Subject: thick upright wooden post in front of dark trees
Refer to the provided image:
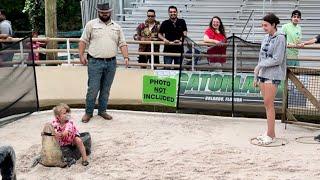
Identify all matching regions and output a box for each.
[45,0,58,60]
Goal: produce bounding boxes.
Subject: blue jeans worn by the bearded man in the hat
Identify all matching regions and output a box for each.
[86,58,117,115]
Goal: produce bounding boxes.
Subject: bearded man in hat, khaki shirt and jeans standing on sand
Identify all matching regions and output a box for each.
[79,3,129,123]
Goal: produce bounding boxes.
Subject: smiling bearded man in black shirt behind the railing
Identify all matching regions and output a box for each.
[158,6,187,67]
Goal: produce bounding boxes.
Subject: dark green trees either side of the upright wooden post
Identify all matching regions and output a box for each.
[0,0,82,33]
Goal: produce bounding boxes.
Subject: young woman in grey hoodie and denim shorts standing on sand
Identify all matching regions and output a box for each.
[254,13,286,145]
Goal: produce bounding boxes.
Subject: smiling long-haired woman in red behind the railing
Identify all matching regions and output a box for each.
[203,16,227,67]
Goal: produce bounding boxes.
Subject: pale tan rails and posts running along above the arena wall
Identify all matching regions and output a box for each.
[0,38,320,70]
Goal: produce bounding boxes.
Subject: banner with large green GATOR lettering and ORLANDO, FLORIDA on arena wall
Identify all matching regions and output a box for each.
[157,70,283,105]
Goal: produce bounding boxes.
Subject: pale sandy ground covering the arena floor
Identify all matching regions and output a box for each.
[0,110,320,180]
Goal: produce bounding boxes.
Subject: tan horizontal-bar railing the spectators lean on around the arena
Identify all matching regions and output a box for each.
[0,38,320,70]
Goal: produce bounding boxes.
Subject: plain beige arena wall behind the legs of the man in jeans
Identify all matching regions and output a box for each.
[36,66,154,107]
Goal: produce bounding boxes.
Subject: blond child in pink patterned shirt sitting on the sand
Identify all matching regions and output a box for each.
[52,103,89,166]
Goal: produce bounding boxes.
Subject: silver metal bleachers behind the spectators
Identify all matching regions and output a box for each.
[118,0,320,64]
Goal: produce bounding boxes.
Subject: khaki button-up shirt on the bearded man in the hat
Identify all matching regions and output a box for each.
[80,18,127,58]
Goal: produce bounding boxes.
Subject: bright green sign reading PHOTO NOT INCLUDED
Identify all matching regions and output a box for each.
[142,76,177,107]
